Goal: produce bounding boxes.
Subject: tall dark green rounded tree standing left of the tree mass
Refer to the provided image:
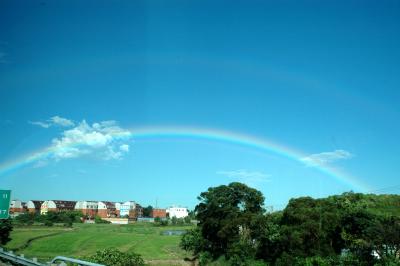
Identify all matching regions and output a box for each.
[195,182,264,258]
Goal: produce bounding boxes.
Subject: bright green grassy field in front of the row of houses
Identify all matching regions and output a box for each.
[6,223,194,265]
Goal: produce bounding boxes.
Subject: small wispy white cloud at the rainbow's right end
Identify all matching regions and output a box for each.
[301,150,354,167]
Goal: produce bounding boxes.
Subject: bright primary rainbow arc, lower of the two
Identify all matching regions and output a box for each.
[0,127,370,191]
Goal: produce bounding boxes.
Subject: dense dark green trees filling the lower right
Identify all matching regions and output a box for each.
[181,183,400,265]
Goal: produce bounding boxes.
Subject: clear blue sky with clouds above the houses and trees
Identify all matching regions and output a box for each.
[0,1,400,208]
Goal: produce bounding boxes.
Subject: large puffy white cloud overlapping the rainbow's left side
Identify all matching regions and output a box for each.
[36,120,131,161]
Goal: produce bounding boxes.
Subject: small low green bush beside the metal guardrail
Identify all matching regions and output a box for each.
[86,248,145,266]
